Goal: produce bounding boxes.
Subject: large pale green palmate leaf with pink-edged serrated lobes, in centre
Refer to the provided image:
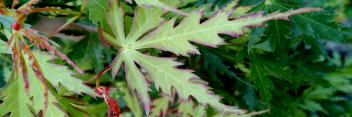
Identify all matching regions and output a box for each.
[99,1,320,114]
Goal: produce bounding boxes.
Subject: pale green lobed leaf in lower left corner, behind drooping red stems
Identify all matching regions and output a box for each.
[0,53,96,117]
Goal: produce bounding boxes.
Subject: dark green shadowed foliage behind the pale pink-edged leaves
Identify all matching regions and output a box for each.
[0,0,352,117]
